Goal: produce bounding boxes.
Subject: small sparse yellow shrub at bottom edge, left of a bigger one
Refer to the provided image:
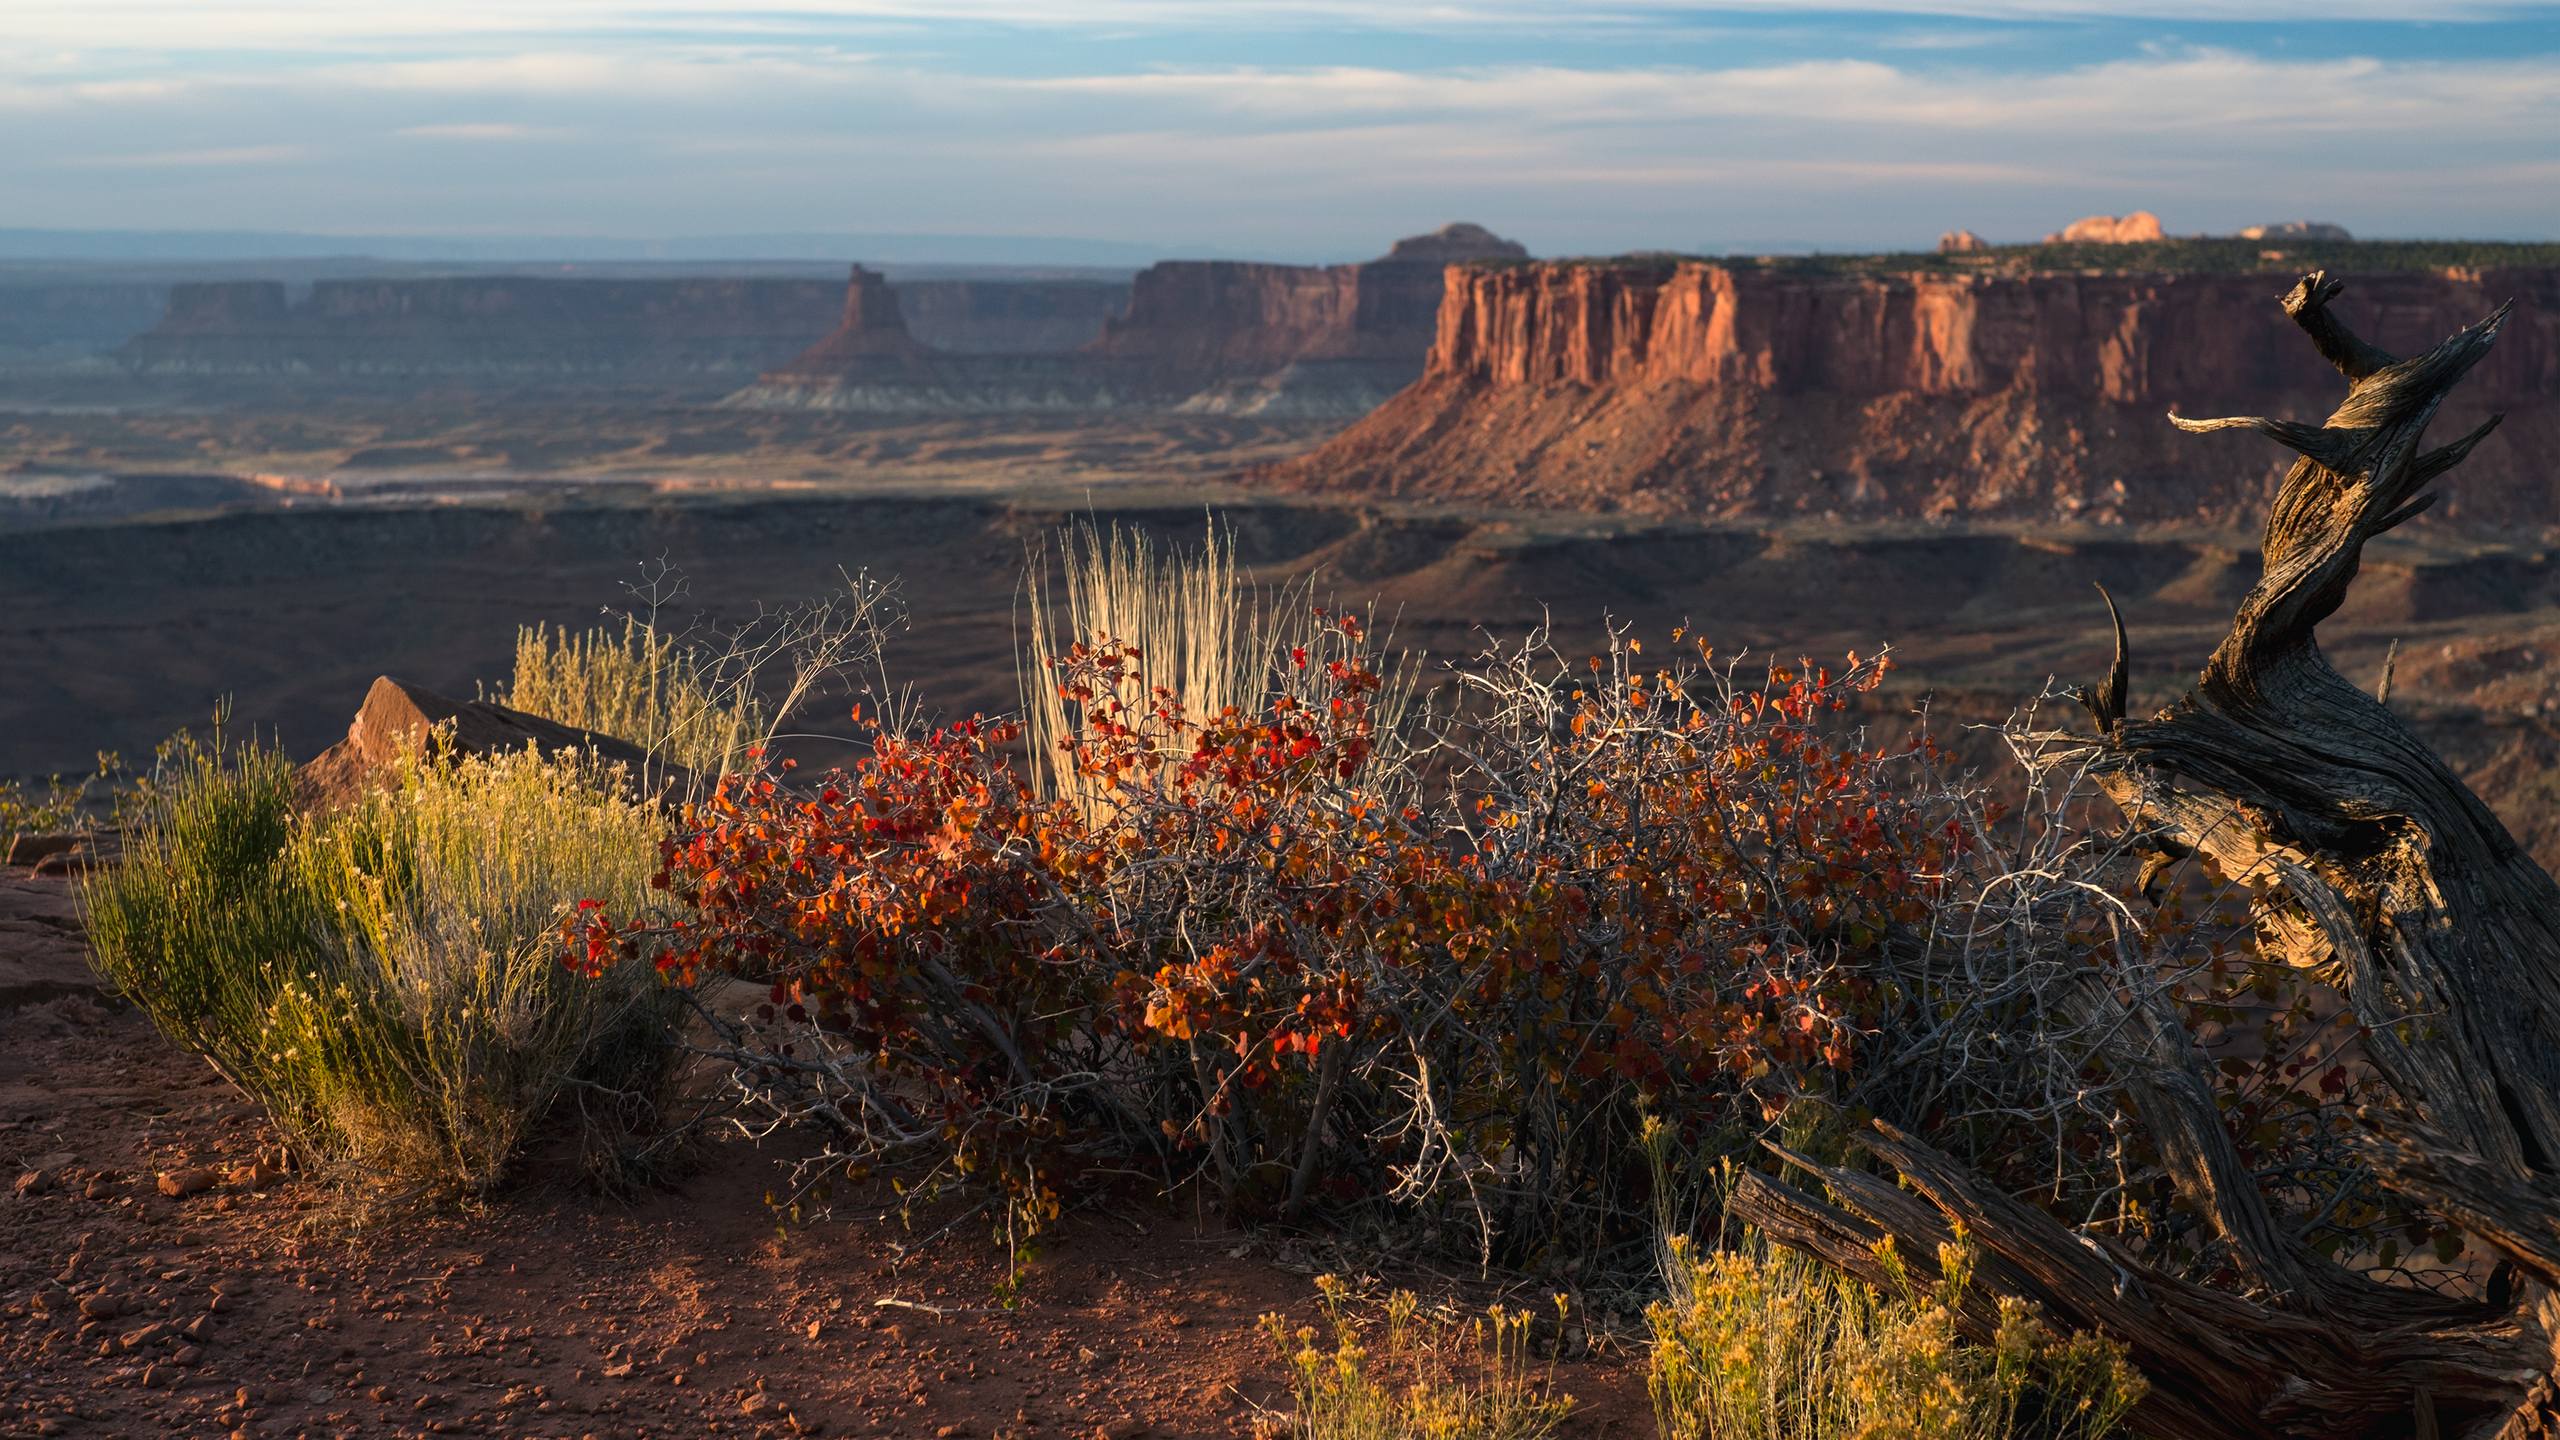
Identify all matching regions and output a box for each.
[1262,1276,1574,1440]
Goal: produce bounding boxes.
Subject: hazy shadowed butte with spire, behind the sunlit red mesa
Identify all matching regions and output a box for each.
[730,225,1526,415]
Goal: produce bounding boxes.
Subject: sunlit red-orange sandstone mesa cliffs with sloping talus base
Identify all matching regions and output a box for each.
[1252,259,2560,530]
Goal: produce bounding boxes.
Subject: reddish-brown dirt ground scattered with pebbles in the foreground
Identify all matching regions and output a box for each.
[0,871,1651,1440]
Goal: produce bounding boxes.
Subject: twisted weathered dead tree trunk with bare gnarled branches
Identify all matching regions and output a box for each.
[1738,272,2560,1437]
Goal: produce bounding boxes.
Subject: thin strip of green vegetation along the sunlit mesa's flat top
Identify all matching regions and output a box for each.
[1477,236,2560,274]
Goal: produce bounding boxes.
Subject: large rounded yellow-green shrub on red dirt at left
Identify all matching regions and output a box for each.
[82,740,673,1191]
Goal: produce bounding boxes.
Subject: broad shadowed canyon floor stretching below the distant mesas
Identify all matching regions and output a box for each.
[0,409,2560,858]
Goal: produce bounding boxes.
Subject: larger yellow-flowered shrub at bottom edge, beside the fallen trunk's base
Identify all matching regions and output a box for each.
[1646,1219,2143,1440]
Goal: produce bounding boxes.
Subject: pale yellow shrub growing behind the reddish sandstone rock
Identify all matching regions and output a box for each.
[489,615,771,774]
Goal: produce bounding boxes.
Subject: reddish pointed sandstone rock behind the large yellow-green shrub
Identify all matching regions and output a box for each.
[294,676,686,812]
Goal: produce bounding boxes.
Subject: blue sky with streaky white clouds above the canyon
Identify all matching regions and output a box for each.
[0,0,2560,259]
